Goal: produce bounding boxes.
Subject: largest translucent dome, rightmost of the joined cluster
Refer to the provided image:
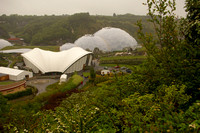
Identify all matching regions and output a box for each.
[94,27,137,51]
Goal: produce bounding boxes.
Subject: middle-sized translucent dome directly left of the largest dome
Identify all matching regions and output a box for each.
[75,35,111,51]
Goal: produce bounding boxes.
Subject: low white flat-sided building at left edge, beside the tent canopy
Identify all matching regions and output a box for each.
[0,67,33,81]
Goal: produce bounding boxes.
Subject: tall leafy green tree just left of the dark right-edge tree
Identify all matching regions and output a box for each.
[137,0,183,90]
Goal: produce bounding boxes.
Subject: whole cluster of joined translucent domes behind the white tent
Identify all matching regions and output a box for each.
[60,27,137,52]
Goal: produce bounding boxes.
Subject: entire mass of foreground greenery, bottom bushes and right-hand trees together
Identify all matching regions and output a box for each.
[0,0,200,133]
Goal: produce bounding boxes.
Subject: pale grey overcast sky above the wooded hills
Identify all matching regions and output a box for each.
[0,0,186,17]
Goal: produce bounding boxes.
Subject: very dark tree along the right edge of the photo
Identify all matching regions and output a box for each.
[185,0,200,94]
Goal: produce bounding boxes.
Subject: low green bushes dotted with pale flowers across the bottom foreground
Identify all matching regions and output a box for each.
[9,77,200,132]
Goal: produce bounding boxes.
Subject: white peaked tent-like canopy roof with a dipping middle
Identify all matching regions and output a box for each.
[22,47,91,73]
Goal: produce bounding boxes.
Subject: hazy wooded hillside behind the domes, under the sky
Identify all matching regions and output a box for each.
[0,13,153,45]
